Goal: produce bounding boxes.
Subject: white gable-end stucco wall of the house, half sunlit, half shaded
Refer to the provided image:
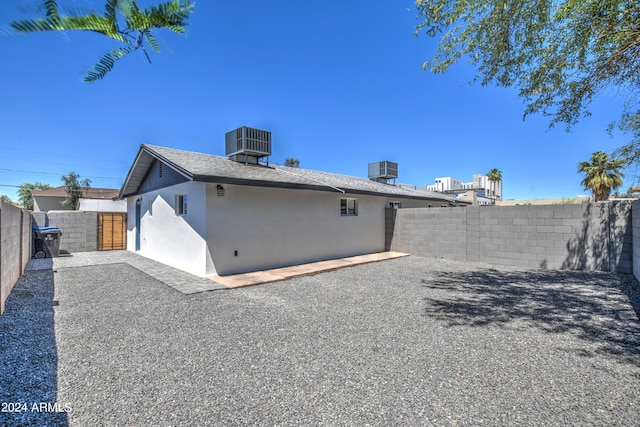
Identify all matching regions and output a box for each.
[127,182,215,276]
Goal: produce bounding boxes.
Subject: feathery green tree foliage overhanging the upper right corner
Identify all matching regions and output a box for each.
[416,0,640,159]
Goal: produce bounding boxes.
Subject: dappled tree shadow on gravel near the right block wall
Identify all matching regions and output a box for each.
[422,269,640,366]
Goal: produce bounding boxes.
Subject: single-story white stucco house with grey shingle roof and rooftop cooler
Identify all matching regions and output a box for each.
[120,127,464,276]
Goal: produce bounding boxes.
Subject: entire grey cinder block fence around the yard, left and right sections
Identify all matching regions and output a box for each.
[0,200,640,313]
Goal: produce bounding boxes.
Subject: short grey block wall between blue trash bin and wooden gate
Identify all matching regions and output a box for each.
[32,211,98,253]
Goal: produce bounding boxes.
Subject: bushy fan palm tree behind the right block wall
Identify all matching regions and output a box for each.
[578,151,626,202]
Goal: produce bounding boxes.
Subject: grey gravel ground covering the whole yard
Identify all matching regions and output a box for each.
[0,257,640,426]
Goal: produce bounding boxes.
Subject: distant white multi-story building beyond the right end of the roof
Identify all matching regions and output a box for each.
[425,173,502,205]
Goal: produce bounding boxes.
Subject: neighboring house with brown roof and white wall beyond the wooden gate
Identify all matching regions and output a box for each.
[31,185,126,212]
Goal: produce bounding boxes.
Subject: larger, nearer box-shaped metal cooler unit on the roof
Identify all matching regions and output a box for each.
[225,126,271,164]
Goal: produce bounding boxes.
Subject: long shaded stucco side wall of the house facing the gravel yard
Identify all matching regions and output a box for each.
[207,184,427,275]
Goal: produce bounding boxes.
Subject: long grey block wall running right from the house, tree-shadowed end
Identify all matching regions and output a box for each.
[390,202,640,273]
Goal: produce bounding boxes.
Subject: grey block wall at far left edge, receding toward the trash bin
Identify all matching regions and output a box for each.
[0,201,31,314]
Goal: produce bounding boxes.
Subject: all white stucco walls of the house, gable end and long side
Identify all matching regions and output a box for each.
[127,182,440,276]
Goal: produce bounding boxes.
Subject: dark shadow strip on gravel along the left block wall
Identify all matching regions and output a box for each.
[0,270,68,426]
